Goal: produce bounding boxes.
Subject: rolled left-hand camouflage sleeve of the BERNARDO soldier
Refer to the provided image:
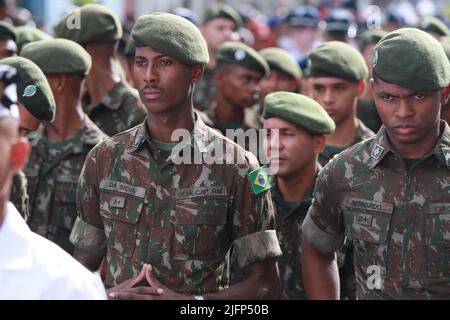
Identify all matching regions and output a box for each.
[302,161,345,252]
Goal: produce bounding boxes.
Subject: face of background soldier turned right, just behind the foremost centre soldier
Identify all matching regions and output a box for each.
[214,65,263,108]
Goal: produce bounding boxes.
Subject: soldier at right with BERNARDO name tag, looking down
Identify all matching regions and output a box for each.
[302,28,450,299]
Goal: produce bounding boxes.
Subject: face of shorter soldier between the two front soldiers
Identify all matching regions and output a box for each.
[264,117,325,178]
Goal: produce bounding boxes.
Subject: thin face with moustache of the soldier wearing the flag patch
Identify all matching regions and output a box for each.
[134,47,203,113]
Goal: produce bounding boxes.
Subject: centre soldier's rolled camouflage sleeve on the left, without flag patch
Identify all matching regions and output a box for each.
[70,146,106,257]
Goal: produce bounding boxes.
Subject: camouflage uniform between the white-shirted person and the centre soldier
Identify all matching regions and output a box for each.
[24,116,106,253]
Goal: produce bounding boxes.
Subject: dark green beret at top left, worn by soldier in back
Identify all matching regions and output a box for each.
[54,4,122,43]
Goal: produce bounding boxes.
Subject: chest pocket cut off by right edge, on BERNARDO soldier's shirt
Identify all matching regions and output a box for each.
[425,203,450,278]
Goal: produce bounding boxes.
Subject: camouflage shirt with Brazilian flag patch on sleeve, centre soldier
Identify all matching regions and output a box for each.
[71,115,281,294]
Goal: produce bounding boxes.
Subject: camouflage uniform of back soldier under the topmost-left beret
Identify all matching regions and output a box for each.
[83,82,147,136]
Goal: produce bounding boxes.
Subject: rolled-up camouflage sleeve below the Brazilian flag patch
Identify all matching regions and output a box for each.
[233,154,281,268]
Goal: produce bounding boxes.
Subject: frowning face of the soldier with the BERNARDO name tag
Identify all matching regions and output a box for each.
[371,79,448,156]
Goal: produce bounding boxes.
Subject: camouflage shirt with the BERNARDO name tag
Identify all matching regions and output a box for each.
[303,121,450,299]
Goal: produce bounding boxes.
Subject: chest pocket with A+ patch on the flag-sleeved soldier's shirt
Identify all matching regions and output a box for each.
[100,182,145,258]
